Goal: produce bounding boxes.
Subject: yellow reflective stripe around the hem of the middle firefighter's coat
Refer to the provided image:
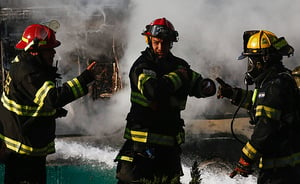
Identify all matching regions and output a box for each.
[124,128,185,146]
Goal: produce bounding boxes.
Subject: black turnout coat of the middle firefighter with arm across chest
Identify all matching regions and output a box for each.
[117,48,211,162]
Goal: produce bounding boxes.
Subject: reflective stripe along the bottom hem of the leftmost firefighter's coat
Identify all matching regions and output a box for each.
[0,134,55,156]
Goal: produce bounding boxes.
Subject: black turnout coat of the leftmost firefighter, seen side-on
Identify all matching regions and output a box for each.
[0,53,93,156]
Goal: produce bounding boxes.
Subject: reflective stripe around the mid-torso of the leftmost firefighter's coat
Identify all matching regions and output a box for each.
[1,92,56,117]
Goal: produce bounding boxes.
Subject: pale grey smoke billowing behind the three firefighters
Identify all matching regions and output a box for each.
[0,0,300,135]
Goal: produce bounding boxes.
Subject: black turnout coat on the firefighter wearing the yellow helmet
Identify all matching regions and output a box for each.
[232,63,300,171]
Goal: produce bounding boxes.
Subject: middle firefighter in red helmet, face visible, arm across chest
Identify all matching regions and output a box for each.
[116,18,216,184]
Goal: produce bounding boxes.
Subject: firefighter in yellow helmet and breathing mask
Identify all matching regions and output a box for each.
[217,30,300,184]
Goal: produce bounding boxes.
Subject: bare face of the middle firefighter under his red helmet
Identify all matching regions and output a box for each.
[151,37,171,58]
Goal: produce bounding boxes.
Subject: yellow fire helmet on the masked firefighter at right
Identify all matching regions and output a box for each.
[238,30,294,59]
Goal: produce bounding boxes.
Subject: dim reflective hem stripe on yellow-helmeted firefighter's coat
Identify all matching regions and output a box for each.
[259,152,300,169]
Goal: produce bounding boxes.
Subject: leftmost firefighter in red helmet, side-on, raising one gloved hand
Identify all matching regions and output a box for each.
[0,24,96,184]
